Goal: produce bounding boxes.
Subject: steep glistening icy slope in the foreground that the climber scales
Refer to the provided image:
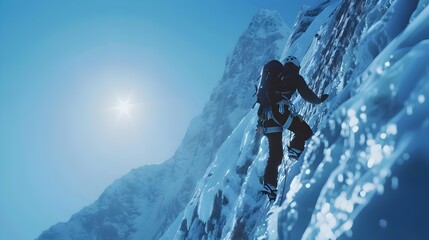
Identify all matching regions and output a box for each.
[168,0,429,239]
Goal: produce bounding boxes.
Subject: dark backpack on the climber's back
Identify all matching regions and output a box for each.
[256,60,285,106]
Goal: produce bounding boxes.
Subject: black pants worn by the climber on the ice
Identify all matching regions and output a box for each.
[264,117,313,187]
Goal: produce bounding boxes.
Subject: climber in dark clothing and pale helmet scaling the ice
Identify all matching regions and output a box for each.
[257,56,328,200]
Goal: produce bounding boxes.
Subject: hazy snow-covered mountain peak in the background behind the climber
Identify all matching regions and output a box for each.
[38,10,289,240]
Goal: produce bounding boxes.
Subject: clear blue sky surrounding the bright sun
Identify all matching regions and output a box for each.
[0,0,311,240]
